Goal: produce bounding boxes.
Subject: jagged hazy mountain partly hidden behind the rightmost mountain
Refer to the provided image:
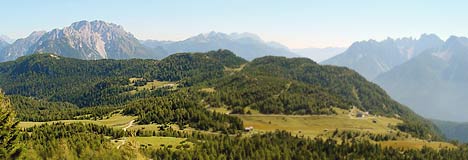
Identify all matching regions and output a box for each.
[322,34,443,80]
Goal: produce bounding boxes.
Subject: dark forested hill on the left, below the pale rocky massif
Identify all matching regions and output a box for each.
[0,50,246,106]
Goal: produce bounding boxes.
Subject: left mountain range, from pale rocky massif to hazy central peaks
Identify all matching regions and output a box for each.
[0,21,299,61]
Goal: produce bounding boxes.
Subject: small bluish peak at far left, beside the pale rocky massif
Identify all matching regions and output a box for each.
[0,31,45,61]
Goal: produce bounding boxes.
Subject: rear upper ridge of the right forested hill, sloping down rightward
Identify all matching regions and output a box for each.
[243,57,415,122]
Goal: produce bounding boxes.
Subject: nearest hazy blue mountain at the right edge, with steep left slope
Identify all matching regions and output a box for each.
[375,36,468,121]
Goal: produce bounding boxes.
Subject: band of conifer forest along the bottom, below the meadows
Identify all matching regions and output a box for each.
[12,123,468,160]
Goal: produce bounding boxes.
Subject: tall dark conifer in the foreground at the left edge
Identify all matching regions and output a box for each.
[0,90,21,159]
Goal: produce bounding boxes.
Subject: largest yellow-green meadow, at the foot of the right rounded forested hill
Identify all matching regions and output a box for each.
[236,109,401,138]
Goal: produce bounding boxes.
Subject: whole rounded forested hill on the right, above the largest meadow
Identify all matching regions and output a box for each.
[203,56,440,138]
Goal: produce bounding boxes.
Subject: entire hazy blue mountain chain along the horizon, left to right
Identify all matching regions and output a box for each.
[0,21,468,125]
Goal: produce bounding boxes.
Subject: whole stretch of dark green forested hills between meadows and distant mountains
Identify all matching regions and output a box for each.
[0,50,439,138]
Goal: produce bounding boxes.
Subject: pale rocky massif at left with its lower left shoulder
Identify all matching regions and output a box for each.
[3,21,165,60]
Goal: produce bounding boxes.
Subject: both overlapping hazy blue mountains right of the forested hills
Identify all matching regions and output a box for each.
[323,34,468,121]
